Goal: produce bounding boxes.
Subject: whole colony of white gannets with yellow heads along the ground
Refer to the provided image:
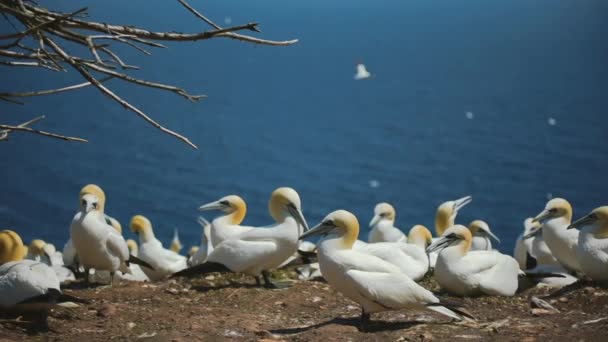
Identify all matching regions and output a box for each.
[0,184,608,324]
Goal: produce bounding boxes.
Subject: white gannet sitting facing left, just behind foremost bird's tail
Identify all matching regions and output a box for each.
[428,225,520,296]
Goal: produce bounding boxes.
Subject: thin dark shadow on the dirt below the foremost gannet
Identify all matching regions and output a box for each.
[269,317,428,335]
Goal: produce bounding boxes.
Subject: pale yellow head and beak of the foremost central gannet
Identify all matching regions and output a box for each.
[300,210,359,249]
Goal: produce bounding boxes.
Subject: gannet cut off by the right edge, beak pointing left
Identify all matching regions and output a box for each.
[568,206,608,284]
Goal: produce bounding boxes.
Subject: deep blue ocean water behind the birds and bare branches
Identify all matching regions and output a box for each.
[0,0,608,251]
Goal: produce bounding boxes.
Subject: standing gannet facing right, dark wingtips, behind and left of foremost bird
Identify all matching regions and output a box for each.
[175,187,308,288]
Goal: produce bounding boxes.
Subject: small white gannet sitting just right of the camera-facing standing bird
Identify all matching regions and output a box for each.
[130,215,188,281]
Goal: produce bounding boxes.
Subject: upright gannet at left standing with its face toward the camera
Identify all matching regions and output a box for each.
[70,184,149,285]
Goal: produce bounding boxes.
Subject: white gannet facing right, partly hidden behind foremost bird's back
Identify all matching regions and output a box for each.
[352,225,433,281]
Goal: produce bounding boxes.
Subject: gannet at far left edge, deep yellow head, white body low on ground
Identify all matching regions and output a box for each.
[0,230,80,308]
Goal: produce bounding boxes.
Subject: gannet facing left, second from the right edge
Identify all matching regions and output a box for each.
[524,198,581,272]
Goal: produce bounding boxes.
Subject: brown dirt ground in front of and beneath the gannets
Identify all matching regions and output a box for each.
[0,273,608,342]
